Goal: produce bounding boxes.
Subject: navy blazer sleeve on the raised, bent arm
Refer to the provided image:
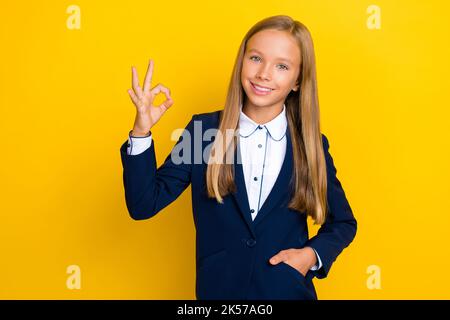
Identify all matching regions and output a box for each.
[120,115,196,220]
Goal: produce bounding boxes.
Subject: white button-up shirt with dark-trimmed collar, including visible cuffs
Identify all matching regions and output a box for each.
[127,104,322,270]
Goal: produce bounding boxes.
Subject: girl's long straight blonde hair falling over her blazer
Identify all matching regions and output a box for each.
[206,15,327,224]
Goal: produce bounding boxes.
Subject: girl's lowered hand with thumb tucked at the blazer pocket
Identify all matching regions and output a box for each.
[270,247,317,277]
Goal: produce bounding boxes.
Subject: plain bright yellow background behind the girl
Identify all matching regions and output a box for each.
[0,0,450,299]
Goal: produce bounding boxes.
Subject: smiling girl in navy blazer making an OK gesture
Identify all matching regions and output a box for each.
[121,15,357,299]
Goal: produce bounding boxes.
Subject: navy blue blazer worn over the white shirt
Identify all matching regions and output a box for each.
[120,110,357,300]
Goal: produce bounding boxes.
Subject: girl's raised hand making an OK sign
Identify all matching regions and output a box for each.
[128,59,173,134]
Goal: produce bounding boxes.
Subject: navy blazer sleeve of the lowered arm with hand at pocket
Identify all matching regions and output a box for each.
[305,134,357,279]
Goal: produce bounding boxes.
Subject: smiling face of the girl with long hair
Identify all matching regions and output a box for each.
[241,29,301,111]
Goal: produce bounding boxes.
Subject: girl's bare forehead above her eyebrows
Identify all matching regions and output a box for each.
[246,29,300,64]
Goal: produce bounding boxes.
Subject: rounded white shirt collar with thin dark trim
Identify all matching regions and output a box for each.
[239,104,287,140]
